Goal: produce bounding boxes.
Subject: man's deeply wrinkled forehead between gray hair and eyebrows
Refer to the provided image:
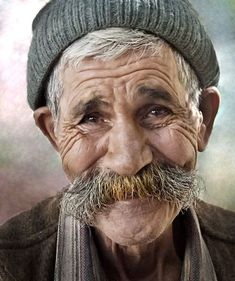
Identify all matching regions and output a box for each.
[61,48,188,109]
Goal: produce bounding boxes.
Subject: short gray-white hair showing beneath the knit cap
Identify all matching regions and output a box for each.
[46,28,201,119]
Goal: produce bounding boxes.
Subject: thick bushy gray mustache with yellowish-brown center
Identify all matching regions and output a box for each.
[61,163,203,225]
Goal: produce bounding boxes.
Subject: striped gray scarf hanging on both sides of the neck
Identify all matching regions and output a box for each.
[54,202,217,281]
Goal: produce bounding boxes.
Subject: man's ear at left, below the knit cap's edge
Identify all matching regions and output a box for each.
[33,106,58,151]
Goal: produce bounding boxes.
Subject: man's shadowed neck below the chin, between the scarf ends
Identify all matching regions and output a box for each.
[94,221,182,281]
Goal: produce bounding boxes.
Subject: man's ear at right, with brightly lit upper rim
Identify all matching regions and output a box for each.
[198,87,220,152]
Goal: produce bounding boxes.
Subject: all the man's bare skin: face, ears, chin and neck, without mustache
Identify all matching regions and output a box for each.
[35,46,219,281]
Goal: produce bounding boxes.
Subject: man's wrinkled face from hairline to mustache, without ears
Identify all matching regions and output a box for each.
[58,47,201,179]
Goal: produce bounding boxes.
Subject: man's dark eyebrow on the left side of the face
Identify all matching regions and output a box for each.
[68,96,108,117]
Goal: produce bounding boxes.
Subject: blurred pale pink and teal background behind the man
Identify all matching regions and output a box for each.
[0,0,235,224]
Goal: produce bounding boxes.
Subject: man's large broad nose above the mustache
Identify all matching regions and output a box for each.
[102,118,153,175]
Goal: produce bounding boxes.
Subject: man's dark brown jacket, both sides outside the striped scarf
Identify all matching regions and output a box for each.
[0,197,235,281]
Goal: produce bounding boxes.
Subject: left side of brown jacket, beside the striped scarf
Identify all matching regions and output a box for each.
[0,196,60,281]
